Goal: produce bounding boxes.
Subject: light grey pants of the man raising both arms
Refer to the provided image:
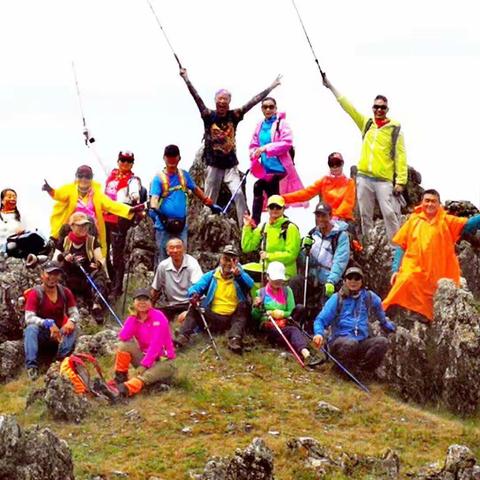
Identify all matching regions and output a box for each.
[205,165,247,228]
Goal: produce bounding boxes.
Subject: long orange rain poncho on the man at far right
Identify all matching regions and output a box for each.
[383,206,468,321]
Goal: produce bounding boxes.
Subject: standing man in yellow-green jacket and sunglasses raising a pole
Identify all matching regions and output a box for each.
[323,76,408,240]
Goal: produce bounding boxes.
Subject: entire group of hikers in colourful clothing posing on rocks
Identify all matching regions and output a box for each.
[4,58,480,400]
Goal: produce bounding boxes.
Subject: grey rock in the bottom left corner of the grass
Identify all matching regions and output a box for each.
[0,416,74,480]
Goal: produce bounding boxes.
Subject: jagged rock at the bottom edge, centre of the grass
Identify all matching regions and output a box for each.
[191,438,274,480]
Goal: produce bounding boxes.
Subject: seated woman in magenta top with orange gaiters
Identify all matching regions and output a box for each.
[102,289,175,401]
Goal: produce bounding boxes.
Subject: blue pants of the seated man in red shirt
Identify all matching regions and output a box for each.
[23,325,78,368]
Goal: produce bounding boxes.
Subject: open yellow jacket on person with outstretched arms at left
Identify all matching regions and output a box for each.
[50,182,132,257]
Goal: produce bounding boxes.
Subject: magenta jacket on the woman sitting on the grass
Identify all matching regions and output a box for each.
[118,308,175,368]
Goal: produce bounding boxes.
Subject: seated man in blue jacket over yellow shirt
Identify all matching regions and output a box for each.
[176,245,253,353]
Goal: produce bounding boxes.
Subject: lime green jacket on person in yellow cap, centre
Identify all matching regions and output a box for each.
[242,217,301,278]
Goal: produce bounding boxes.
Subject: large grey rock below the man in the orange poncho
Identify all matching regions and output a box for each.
[385,279,480,415]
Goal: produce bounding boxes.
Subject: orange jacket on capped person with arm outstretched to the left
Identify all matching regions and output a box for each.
[282,175,355,220]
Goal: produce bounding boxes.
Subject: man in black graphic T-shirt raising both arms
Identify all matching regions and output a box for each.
[180,68,281,228]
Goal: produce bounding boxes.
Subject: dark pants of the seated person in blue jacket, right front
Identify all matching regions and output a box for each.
[329,337,388,372]
